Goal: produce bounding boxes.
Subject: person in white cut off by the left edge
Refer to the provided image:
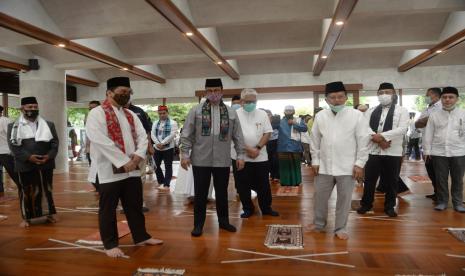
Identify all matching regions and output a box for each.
[0,105,19,193]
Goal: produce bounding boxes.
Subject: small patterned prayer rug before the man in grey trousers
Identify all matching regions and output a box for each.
[265,224,304,249]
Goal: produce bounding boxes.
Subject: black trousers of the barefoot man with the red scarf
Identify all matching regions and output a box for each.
[98,177,151,249]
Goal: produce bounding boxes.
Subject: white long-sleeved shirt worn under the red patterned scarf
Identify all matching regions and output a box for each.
[86,106,148,184]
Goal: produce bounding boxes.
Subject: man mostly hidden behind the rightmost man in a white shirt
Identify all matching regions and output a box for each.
[415,87,442,201]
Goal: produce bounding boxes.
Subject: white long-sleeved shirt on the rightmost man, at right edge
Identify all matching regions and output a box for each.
[423,107,465,157]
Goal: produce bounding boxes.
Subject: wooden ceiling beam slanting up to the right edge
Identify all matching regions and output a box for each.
[397,29,465,72]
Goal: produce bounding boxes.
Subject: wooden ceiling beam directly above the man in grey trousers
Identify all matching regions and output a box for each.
[313,0,358,76]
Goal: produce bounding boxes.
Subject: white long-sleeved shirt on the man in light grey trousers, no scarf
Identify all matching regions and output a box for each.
[310,108,370,176]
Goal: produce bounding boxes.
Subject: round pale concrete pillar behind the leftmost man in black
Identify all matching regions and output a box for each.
[19,57,69,173]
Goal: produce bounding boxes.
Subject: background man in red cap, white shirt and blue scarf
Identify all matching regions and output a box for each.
[151,105,178,190]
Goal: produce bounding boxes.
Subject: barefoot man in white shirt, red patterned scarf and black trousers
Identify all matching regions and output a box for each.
[86,77,162,257]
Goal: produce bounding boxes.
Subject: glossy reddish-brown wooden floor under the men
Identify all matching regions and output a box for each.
[0,162,465,275]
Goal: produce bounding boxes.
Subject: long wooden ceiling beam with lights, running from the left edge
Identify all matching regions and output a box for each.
[0,12,166,83]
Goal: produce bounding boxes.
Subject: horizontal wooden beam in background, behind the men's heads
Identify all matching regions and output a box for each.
[195,83,363,97]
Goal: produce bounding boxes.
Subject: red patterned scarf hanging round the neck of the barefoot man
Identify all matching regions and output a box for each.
[102,100,137,153]
